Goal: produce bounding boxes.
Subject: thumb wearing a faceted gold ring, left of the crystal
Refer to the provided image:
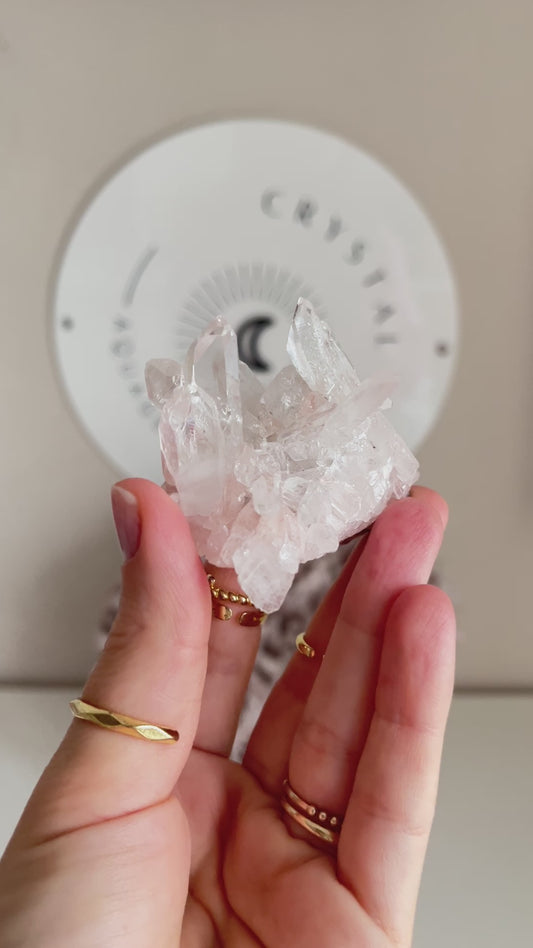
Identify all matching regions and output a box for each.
[15,479,211,837]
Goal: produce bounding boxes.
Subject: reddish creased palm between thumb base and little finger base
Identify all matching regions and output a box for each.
[175,751,388,948]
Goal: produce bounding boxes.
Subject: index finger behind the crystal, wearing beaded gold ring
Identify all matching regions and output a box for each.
[194,566,261,755]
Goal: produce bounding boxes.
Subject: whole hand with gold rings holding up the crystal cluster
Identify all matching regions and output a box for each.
[0,479,455,948]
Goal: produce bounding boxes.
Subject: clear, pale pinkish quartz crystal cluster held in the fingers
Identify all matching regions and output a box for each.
[146,300,418,612]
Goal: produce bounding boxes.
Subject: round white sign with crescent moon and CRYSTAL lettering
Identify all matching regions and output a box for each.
[53,119,457,480]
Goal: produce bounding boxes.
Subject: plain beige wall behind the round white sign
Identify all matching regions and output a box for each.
[0,0,533,685]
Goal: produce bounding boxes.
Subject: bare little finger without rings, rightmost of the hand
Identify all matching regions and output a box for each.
[338,586,455,944]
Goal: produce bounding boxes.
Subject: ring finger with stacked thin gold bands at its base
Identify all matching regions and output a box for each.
[288,497,444,813]
